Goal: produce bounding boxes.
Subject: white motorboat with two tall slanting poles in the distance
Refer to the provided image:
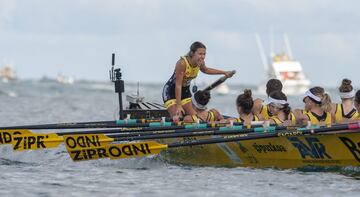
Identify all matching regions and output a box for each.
[256,34,311,95]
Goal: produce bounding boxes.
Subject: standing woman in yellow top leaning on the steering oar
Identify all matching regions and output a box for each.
[162,42,233,118]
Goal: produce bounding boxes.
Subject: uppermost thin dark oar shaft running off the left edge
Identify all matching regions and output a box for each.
[0,118,175,130]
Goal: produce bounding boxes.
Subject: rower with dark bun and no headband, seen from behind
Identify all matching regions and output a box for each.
[232,89,263,125]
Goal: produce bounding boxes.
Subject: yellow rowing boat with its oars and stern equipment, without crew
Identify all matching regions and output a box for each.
[0,55,360,168]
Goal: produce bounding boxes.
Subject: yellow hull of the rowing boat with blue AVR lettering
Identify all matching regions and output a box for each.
[162,132,360,168]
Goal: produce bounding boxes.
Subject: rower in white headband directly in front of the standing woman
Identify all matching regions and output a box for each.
[184,90,224,122]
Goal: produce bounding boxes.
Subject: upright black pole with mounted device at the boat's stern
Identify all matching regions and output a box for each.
[109,53,125,119]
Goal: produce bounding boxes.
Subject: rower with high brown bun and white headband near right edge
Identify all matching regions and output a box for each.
[331,79,359,123]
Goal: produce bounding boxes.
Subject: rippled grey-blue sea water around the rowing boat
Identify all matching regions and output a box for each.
[0,81,360,197]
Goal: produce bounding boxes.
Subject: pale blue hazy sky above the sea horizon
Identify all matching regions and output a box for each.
[0,0,360,86]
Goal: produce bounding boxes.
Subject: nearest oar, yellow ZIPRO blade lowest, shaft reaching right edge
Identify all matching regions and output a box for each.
[65,122,360,161]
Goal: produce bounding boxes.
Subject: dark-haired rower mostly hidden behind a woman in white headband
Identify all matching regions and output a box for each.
[252,79,283,120]
